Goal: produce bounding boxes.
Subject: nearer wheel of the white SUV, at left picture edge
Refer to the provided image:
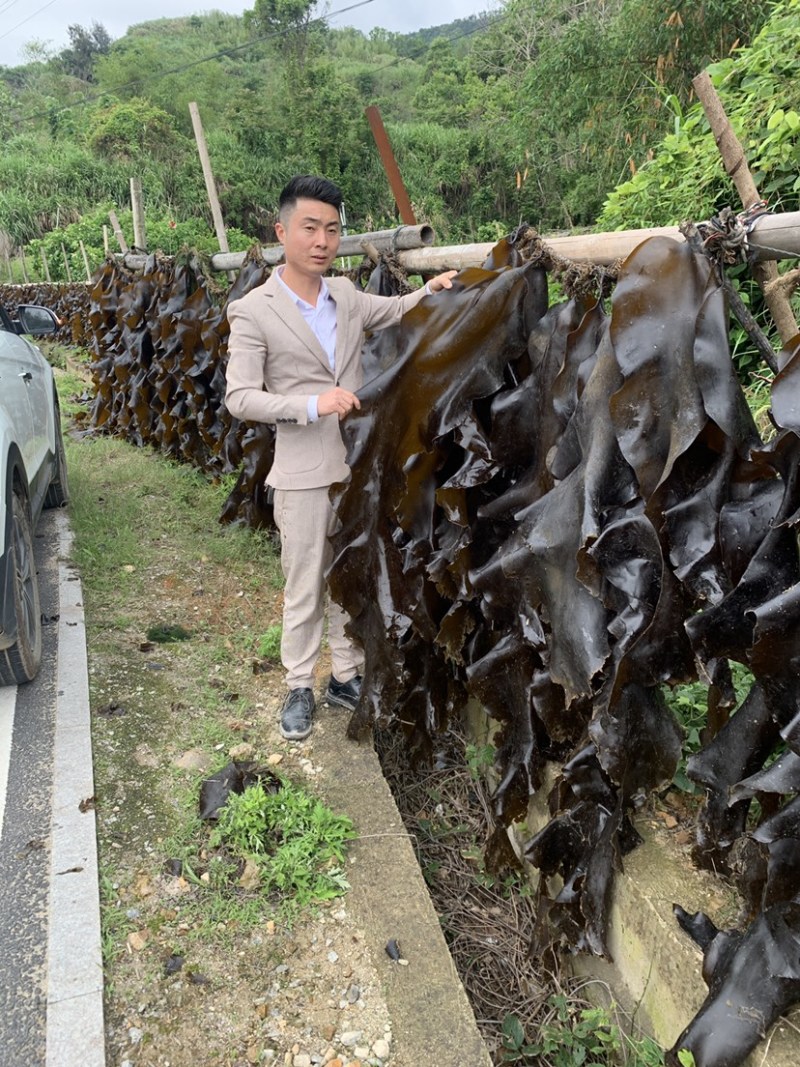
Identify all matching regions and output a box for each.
[0,489,42,685]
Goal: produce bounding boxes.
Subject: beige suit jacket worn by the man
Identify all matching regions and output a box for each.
[225,273,425,489]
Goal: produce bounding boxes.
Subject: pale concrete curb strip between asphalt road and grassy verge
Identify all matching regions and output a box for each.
[45,511,106,1067]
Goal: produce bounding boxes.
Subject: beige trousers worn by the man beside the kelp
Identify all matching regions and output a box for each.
[274,487,364,689]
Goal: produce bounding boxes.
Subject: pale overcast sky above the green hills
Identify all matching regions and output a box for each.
[0,0,501,66]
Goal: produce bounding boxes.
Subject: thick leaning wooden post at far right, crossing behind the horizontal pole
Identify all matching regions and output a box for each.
[692,70,798,345]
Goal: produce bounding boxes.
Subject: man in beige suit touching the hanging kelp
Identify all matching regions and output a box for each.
[225,175,457,740]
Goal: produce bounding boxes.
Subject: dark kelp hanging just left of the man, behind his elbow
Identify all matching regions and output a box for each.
[82,243,273,526]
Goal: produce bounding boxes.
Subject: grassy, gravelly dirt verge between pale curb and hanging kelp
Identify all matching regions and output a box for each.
[70,426,489,1067]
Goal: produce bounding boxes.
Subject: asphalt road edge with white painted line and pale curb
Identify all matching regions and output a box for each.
[0,511,105,1067]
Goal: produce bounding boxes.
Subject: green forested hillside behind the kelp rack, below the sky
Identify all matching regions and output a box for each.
[0,0,800,277]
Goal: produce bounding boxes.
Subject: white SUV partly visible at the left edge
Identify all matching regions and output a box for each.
[0,304,68,685]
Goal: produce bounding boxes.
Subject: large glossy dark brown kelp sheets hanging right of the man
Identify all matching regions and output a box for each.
[330,238,800,1067]
